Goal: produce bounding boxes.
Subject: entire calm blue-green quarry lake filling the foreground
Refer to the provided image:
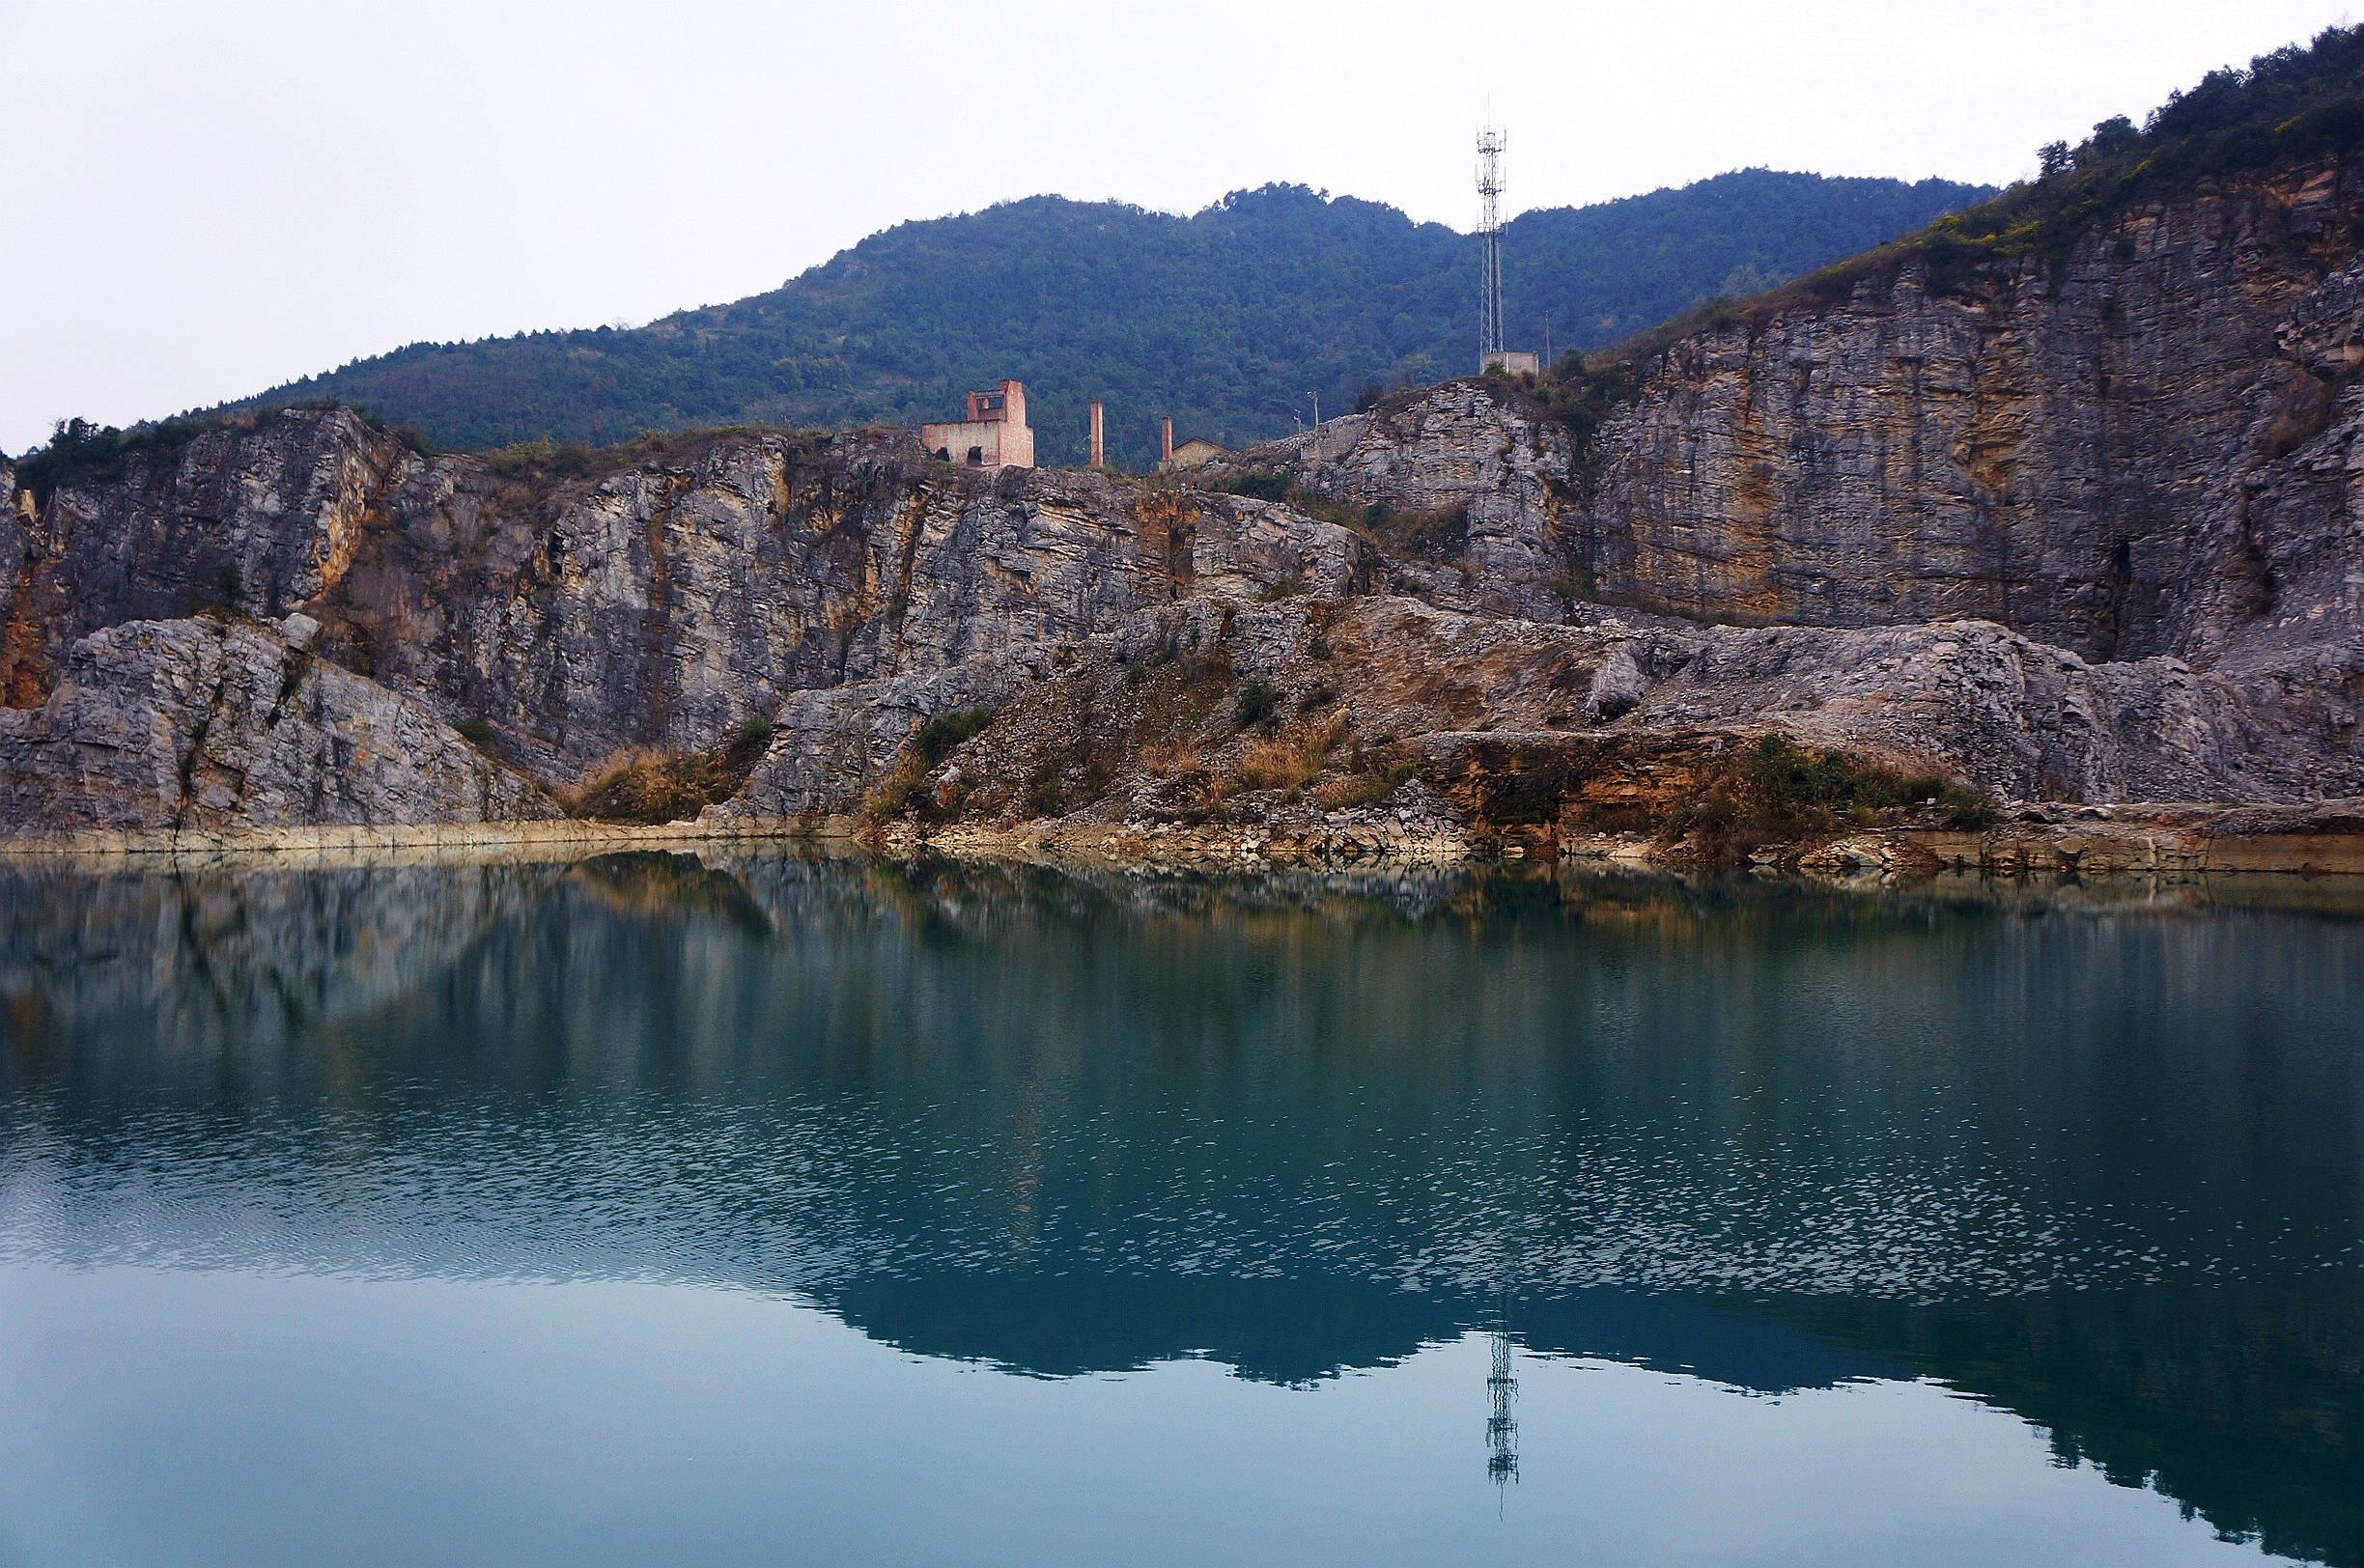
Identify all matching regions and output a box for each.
[0,854,2364,1568]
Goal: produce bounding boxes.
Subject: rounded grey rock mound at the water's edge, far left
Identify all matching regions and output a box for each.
[0,620,560,835]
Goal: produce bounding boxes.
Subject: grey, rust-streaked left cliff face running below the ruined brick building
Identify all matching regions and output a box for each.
[0,411,1381,775]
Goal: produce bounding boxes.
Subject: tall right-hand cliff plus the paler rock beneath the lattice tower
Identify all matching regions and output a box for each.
[1200,170,2364,790]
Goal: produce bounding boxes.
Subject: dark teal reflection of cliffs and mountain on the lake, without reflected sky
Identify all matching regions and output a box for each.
[0,856,2364,1561]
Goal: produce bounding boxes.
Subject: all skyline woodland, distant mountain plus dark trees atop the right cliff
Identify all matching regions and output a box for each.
[45,28,2364,472]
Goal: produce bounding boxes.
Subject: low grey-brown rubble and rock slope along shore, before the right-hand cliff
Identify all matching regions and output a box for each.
[714,599,2364,821]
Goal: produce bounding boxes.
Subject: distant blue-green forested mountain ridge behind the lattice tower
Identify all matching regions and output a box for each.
[212,168,1988,463]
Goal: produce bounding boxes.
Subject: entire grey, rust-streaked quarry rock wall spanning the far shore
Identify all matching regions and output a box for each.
[14,161,2364,826]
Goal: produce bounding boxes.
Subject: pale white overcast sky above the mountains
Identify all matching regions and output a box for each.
[0,0,2354,452]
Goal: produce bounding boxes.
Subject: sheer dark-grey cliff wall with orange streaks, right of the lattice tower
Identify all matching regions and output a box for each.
[1584,173,2364,659]
